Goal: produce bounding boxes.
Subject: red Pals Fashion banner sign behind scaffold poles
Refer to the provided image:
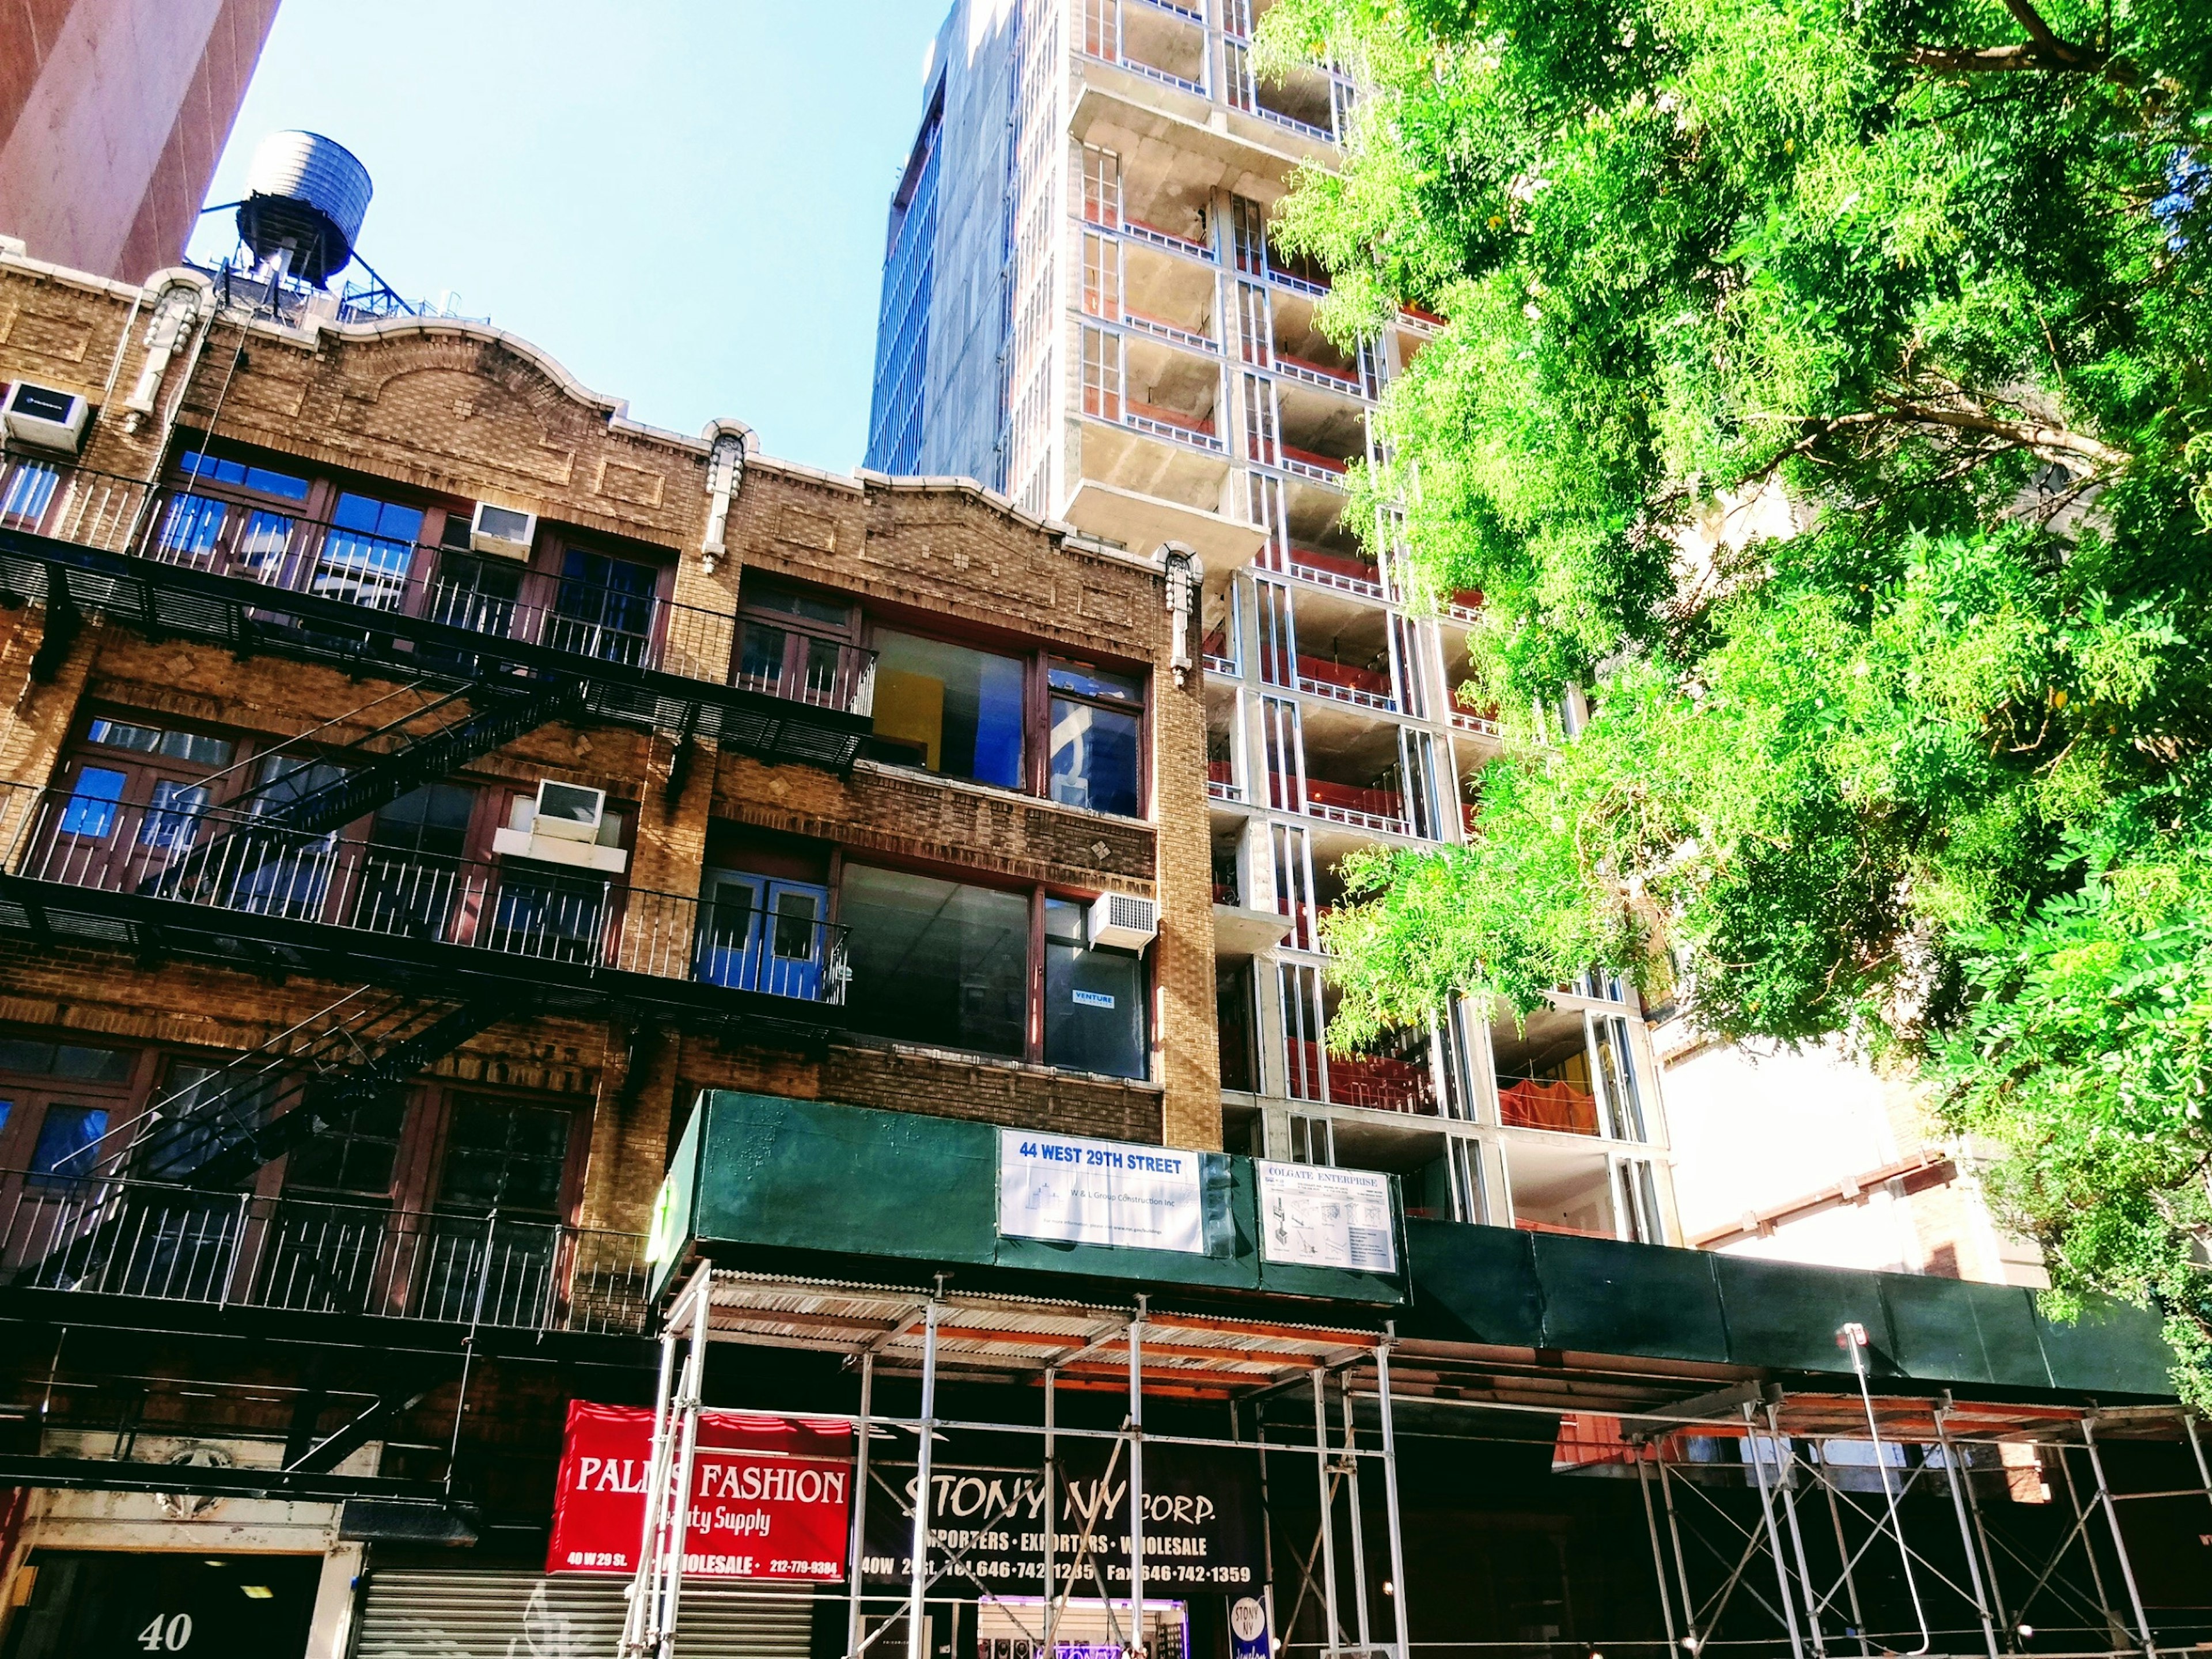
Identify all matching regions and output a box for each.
[546,1400,851,1582]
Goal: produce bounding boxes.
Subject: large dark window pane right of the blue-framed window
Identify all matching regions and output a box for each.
[838,865,1029,1058]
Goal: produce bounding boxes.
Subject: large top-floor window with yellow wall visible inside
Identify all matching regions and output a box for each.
[876,632,1022,790]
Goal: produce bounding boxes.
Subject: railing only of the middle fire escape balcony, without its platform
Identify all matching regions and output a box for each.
[0,787,847,1004]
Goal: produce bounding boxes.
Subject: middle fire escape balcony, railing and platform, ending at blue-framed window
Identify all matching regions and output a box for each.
[0,787,847,1031]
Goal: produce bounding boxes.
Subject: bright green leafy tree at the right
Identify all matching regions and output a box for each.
[1261,0,2212,1398]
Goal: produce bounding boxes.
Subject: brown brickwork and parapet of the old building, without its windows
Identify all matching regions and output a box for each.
[0,261,1221,1256]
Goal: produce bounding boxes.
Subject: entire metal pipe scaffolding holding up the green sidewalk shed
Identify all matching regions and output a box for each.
[622,1267,2212,1659]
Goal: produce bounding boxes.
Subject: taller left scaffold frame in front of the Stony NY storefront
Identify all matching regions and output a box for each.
[622,1267,1411,1659]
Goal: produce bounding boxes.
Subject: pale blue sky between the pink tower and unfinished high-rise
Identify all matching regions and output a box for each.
[192,0,947,471]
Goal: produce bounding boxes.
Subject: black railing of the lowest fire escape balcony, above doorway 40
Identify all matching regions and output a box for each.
[0,1170,648,1334]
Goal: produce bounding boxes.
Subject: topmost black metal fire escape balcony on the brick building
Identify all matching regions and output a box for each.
[0,458,869,770]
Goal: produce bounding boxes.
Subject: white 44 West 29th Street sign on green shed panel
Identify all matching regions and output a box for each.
[998,1128,1206,1256]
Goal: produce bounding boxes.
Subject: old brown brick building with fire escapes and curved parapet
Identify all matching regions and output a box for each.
[0,252,1221,1654]
